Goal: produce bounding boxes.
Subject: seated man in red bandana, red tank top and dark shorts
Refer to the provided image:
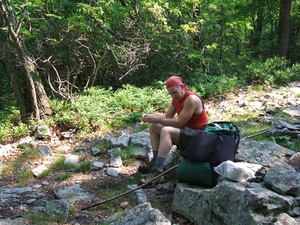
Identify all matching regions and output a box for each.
[138,76,208,185]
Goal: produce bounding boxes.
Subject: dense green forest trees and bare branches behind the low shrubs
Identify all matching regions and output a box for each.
[0,0,300,121]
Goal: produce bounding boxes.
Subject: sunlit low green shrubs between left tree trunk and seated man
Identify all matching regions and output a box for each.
[48,85,170,132]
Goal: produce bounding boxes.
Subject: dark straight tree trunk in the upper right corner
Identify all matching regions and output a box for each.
[277,0,292,57]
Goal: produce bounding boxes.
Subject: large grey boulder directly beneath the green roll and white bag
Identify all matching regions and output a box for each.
[172,179,295,225]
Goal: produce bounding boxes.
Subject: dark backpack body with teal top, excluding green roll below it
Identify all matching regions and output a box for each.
[181,122,240,167]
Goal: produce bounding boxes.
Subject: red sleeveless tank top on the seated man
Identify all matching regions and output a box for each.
[172,91,208,130]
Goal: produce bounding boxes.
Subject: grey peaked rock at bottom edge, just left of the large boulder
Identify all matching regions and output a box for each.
[111,202,171,225]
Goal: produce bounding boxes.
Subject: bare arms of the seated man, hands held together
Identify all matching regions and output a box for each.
[143,95,202,128]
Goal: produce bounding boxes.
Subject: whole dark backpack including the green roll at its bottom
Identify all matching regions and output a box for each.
[176,122,240,188]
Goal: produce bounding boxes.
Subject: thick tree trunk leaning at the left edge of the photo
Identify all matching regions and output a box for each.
[0,1,52,123]
